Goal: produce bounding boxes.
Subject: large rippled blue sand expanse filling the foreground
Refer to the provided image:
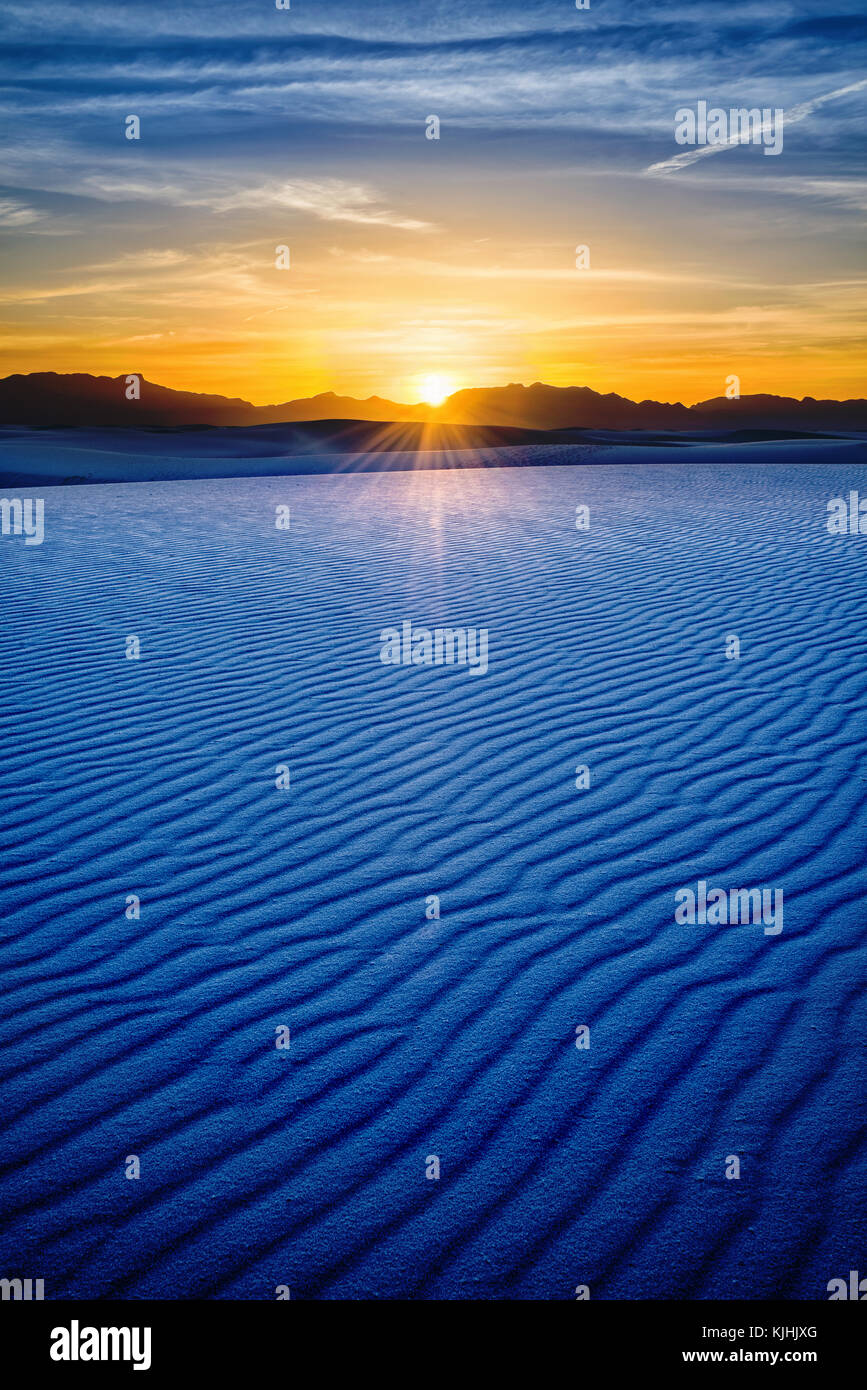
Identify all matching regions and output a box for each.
[0,461,867,1300]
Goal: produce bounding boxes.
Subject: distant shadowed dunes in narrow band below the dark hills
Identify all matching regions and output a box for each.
[0,420,867,488]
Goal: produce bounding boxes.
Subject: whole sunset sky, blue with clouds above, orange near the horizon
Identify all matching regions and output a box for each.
[0,0,867,404]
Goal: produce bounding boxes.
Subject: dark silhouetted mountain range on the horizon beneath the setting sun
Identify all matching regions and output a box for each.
[0,371,867,432]
